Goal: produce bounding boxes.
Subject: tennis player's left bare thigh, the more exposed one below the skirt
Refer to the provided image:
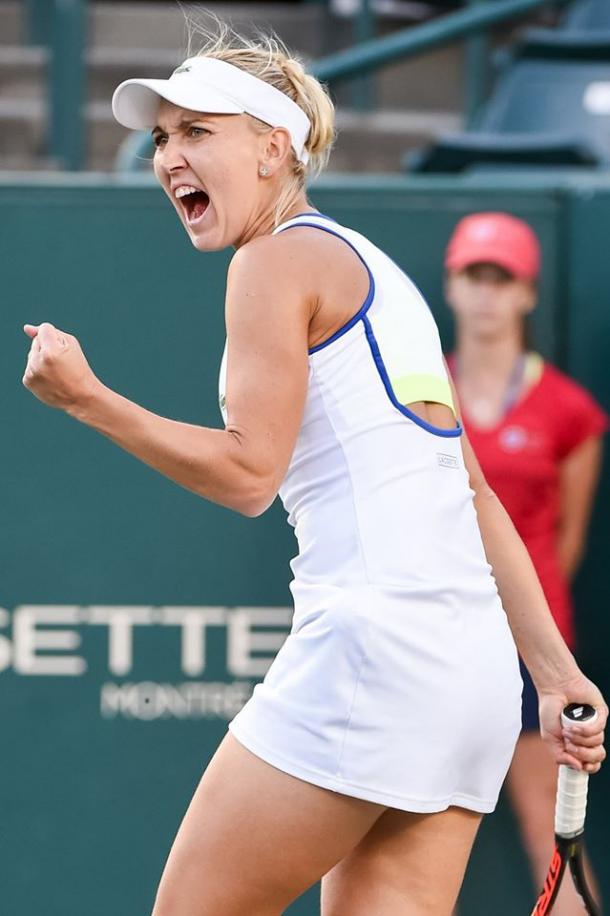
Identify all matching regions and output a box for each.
[152,735,385,916]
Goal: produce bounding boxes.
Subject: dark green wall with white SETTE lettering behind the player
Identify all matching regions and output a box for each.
[0,175,610,916]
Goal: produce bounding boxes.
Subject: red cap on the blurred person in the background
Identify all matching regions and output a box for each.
[445,213,540,281]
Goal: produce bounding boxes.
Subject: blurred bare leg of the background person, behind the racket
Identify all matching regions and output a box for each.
[506,731,597,916]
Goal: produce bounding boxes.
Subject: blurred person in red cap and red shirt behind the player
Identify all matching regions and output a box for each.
[446,213,608,916]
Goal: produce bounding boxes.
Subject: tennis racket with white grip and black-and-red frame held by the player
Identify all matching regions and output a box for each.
[532,703,601,916]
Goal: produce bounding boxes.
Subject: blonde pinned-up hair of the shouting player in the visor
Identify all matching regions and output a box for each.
[185,11,335,226]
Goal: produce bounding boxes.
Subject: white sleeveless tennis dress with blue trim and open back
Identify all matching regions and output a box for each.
[220,213,521,812]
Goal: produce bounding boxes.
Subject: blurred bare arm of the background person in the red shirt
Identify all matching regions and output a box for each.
[557,436,602,579]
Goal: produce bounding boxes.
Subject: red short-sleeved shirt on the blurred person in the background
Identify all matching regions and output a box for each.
[444,363,608,646]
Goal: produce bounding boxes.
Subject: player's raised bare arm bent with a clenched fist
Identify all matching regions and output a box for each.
[24,237,309,515]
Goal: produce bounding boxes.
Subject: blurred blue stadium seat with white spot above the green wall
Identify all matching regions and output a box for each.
[404,29,610,172]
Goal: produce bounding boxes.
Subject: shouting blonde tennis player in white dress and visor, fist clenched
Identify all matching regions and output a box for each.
[24,26,607,916]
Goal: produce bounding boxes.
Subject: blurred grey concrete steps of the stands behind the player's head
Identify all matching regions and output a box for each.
[0,2,462,171]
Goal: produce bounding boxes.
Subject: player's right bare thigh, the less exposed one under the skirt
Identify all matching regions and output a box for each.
[322,808,481,916]
